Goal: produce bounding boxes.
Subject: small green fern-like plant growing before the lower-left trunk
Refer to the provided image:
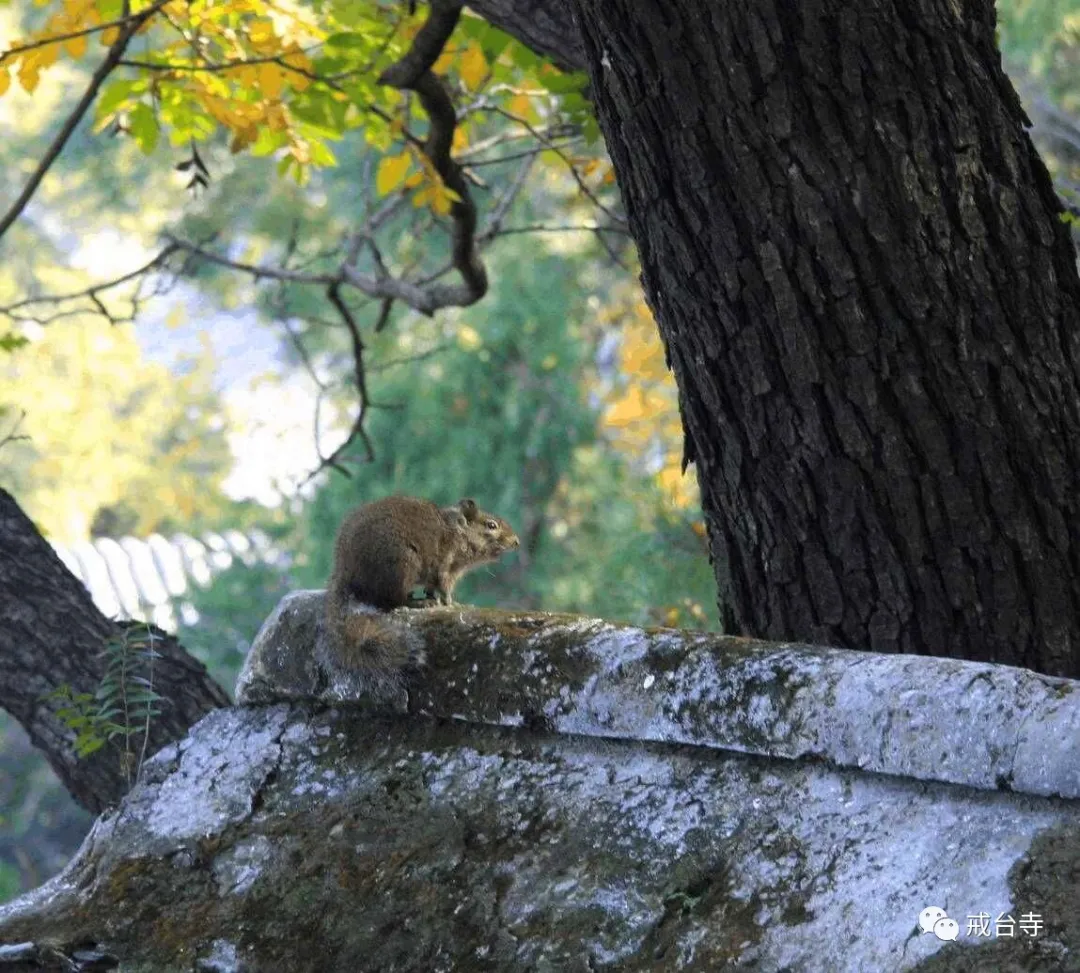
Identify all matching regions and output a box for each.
[46,622,161,787]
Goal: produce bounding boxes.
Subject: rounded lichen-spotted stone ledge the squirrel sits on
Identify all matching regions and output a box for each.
[237,591,1080,797]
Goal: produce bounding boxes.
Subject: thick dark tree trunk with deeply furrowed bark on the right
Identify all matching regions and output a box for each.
[573,0,1080,676]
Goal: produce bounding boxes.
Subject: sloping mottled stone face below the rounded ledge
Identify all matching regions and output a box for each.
[0,704,1080,973]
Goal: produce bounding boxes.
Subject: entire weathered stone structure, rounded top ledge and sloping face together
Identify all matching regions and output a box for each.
[0,592,1080,973]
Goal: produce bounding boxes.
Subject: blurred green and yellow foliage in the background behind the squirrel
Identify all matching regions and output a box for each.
[0,0,1080,901]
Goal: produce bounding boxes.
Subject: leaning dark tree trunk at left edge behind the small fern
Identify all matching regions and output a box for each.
[0,489,229,814]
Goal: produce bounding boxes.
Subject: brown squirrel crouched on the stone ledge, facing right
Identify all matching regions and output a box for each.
[325,497,521,674]
